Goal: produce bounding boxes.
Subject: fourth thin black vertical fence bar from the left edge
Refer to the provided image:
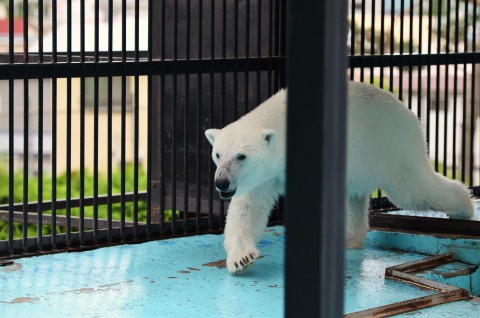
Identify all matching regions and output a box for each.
[51,0,57,249]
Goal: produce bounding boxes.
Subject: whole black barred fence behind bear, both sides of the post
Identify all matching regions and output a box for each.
[0,0,480,256]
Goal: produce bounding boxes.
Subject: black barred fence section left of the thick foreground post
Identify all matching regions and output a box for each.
[0,0,285,255]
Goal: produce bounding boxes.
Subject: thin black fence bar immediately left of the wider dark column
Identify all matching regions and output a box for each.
[133,0,140,239]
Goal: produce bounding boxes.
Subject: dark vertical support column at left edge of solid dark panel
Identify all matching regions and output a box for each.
[148,1,163,223]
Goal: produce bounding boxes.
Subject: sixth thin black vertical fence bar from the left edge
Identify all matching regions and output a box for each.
[79,0,86,245]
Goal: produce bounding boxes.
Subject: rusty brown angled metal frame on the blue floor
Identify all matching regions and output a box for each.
[345,253,470,318]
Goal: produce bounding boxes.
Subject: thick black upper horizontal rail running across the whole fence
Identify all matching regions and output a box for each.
[0,52,480,80]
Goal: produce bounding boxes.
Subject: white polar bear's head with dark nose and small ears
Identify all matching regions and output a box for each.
[205,125,276,199]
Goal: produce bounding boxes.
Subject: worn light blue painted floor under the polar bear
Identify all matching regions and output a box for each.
[0,227,480,318]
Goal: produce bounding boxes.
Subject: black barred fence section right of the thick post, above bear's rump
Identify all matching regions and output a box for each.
[348,0,480,191]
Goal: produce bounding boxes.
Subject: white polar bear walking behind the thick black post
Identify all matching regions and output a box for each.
[205,82,474,273]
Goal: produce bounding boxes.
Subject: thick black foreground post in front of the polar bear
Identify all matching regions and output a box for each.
[285,0,346,317]
